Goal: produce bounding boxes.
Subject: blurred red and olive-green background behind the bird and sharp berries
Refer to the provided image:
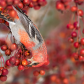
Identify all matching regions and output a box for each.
[0,0,84,84]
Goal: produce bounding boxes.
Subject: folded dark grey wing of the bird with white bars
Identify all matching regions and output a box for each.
[13,7,43,46]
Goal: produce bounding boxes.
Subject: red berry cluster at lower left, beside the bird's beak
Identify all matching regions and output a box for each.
[0,35,32,81]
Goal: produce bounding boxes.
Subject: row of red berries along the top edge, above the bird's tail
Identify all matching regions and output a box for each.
[0,0,47,12]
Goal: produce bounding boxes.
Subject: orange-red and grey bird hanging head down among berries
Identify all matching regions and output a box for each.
[0,6,48,67]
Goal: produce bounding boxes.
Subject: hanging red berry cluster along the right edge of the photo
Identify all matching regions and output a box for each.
[56,0,84,61]
